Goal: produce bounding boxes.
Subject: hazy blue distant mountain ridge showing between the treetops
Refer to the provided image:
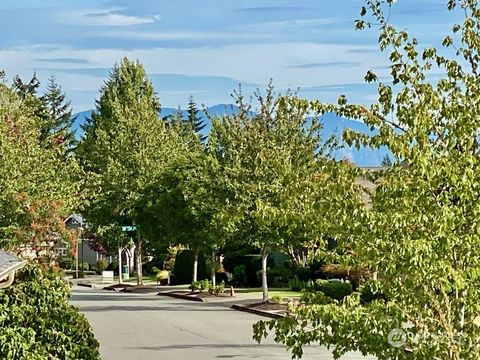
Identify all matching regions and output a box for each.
[73,104,390,167]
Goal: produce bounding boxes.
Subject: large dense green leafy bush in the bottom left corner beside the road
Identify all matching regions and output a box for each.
[0,264,100,360]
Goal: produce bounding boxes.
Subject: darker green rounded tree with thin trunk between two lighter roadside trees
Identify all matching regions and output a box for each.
[140,122,222,281]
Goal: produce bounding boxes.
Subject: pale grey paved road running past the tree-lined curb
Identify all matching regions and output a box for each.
[72,287,372,360]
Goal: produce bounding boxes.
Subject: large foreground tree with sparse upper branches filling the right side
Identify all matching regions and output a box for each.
[255,0,480,359]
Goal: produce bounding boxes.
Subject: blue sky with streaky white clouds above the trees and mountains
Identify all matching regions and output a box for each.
[0,0,458,112]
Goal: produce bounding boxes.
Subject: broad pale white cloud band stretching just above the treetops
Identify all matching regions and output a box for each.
[0,43,386,110]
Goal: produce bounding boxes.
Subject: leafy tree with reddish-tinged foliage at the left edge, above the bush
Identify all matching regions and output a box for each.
[0,73,79,256]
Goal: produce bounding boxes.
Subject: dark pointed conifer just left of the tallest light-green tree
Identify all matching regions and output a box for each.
[40,75,76,148]
